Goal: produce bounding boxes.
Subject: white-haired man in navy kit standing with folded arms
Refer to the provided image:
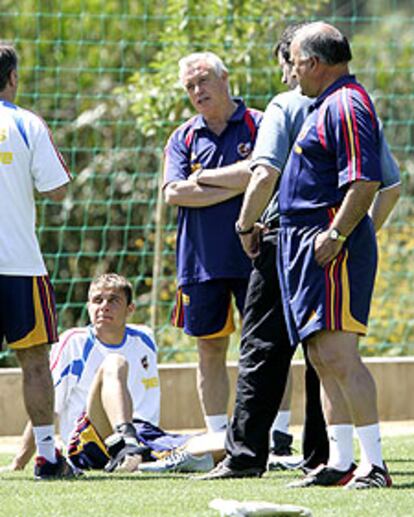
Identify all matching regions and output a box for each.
[164,52,261,432]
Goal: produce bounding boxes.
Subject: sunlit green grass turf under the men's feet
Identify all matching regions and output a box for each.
[0,435,414,517]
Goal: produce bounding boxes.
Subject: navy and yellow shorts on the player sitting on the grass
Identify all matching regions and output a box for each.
[68,414,190,470]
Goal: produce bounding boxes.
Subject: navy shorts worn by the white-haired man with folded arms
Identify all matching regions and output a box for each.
[171,278,248,339]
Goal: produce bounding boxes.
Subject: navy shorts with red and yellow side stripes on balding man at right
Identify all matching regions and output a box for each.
[278,212,377,344]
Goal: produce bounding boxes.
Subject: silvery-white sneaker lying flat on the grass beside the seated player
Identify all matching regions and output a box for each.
[138,449,214,473]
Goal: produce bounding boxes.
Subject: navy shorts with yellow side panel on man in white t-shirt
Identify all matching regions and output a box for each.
[0,275,58,350]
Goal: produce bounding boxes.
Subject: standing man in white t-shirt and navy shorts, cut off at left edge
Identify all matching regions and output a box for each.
[0,43,72,479]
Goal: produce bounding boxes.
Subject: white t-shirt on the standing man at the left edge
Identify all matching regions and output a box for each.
[0,100,71,276]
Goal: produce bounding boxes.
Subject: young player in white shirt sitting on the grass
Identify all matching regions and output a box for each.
[2,274,194,471]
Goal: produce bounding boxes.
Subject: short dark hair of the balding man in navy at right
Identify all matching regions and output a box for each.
[300,26,352,65]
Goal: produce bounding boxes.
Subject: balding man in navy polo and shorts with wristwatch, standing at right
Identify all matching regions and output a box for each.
[278,22,391,489]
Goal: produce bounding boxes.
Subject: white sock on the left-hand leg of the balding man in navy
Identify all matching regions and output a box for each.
[328,424,354,470]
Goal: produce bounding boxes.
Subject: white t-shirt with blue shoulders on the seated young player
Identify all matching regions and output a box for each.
[50,325,160,445]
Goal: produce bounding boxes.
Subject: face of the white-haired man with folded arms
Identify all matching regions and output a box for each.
[182,61,229,118]
